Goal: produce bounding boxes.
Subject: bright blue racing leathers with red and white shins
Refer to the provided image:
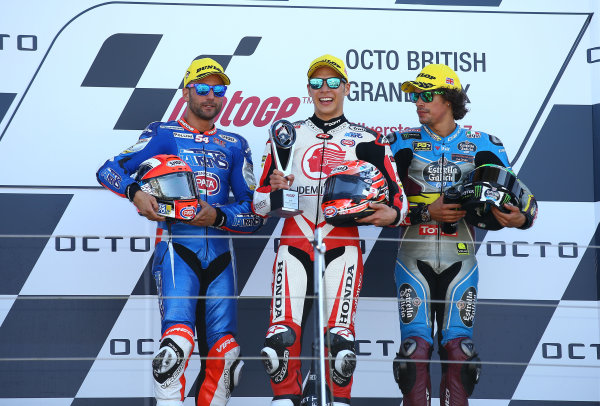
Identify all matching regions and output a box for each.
[97,119,263,406]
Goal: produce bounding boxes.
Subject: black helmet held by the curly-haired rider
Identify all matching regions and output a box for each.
[459,164,530,230]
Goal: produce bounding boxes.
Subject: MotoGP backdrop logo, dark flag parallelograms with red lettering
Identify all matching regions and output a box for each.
[81,34,300,130]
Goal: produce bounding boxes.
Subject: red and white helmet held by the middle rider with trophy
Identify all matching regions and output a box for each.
[321,160,389,227]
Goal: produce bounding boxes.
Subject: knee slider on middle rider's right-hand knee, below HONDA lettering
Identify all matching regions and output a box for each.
[325,327,356,386]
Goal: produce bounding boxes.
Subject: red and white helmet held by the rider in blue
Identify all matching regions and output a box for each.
[135,155,198,220]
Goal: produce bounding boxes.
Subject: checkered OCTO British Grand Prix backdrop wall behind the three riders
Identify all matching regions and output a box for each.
[0,0,600,406]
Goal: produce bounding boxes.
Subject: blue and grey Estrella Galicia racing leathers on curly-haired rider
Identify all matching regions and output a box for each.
[388,125,537,406]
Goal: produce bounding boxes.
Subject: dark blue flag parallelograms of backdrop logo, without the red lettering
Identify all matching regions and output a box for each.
[81,33,262,131]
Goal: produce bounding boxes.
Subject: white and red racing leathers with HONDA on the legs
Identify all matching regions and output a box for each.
[253,115,407,406]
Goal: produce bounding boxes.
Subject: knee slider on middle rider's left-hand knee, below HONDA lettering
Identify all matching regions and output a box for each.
[260,324,296,383]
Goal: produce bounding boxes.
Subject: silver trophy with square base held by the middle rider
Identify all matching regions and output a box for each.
[269,120,302,218]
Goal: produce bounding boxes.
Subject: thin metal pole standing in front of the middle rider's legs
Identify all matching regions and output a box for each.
[314,227,327,406]
